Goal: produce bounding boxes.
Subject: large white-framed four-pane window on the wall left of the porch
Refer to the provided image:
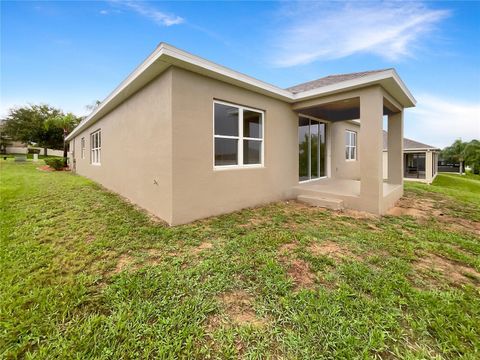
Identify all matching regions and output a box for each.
[214,101,264,168]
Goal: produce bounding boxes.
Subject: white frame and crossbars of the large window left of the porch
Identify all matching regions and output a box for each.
[212,100,265,170]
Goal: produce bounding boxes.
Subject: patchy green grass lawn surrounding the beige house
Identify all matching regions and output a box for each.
[0,159,480,359]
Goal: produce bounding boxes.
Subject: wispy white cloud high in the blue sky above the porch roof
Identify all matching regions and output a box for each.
[270,1,449,67]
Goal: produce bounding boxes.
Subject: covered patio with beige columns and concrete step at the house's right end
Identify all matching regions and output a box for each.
[293,85,410,214]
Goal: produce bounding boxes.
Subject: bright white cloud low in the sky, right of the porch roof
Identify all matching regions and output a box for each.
[405,94,480,148]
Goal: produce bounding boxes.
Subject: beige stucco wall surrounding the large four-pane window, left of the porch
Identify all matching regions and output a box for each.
[172,68,298,224]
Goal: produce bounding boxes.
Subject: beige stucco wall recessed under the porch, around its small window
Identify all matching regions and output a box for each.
[329,121,361,180]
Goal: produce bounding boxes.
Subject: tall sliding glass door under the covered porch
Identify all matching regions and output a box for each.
[298,117,326,181]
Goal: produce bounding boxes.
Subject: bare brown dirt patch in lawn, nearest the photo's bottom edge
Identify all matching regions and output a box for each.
[217,290,266,327]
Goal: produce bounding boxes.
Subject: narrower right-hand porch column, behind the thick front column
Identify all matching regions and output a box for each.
[388,111,403,185]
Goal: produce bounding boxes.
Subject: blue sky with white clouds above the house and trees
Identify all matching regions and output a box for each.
[0,1,480,147]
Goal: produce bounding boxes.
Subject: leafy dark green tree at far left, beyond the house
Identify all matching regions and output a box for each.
[2,104,63,155]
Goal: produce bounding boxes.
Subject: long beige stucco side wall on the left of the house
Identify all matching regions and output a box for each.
[70,70,172,222]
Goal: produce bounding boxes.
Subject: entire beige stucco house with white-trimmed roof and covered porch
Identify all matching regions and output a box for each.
[67,43,415,225]
